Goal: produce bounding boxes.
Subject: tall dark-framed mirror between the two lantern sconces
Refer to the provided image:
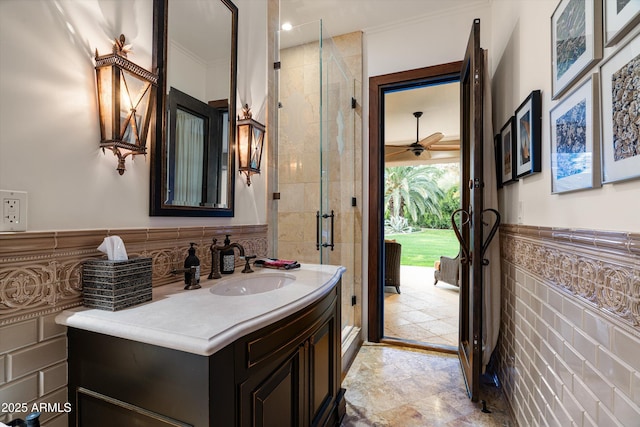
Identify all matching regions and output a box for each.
[150,0,238,217]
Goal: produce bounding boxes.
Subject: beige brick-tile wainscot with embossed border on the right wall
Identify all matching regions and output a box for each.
[498,225,640,427]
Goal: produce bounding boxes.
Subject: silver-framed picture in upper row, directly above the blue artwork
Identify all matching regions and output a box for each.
[551,0,604,99]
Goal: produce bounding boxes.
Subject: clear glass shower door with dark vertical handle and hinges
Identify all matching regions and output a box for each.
[319,25,361,342]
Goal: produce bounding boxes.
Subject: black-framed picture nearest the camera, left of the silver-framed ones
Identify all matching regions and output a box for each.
[513,90,542,178]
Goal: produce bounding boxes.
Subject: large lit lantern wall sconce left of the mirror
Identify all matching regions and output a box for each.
[96,34,158,175]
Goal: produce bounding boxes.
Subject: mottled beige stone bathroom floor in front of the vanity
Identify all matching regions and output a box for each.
[342,343,516,427]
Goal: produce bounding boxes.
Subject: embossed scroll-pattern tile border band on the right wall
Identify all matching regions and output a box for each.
[500,225,640,330]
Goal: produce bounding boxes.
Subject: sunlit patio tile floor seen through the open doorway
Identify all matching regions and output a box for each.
[384,265,460,348]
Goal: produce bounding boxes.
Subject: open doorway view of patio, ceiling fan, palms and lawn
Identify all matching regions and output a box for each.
[382,80,460,352]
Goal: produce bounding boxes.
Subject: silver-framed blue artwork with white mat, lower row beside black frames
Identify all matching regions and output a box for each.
[550,74,600,193]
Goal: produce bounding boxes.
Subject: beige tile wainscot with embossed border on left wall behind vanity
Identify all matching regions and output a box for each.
[0,225,267,427]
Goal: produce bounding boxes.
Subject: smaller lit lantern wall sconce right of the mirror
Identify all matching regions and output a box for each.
[238,104,265,186]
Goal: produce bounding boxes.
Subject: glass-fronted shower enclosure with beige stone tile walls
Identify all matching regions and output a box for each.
[273,21,362,368]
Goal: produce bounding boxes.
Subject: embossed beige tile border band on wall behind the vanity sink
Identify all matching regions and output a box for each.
[0,225,267,326]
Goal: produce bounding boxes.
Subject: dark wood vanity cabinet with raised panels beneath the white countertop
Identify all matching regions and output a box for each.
[68,282,344,427]
